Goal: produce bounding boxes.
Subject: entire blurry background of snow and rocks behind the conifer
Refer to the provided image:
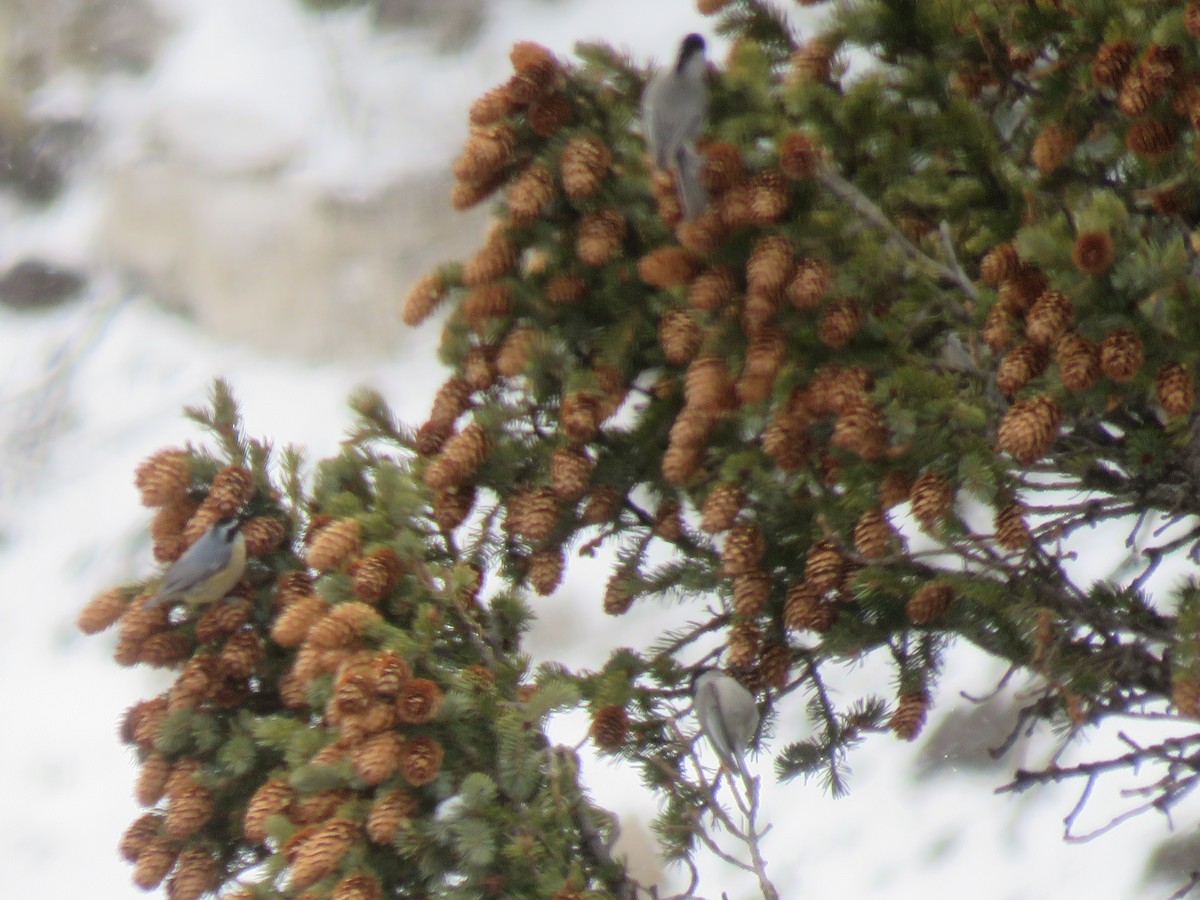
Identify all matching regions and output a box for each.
[0,0,1200,900]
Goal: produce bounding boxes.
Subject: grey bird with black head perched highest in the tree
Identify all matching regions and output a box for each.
[642,34,708,220]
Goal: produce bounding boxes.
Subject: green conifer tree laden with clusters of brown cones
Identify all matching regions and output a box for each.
[79,0,1200,900]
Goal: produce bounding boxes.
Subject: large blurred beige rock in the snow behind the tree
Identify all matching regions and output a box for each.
[100,158,487,360]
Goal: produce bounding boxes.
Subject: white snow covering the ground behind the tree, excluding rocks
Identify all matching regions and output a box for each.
[0,0,1200,900]
